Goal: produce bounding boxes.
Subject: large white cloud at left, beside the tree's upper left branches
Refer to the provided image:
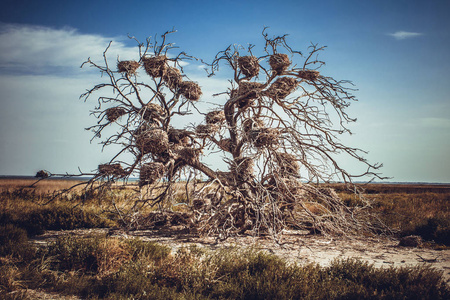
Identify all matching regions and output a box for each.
[0,24,138,73]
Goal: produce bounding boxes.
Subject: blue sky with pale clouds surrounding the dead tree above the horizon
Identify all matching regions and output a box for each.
[0,0,450,182]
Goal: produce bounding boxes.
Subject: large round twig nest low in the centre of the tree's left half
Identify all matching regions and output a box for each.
[135,128,169,154]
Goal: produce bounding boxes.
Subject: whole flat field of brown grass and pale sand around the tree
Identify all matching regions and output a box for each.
[0,179,450,299]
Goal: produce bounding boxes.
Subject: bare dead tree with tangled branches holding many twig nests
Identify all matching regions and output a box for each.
[77,30,380,237]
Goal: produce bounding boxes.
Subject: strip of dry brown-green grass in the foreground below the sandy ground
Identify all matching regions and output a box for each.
[0,236,450,299]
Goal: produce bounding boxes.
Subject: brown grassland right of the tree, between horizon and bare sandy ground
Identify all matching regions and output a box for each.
[348,185,450,248]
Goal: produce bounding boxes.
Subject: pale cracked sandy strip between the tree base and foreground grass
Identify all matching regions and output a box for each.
[34,229,450,283]
